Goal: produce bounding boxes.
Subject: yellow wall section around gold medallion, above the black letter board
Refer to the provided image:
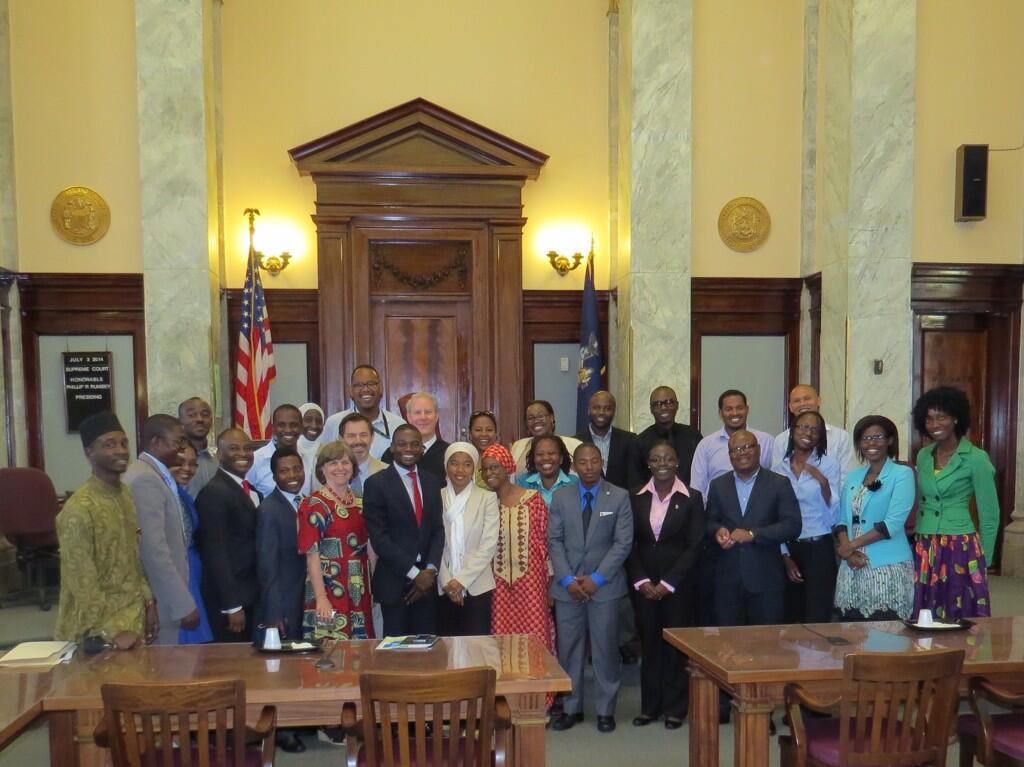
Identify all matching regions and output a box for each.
[8,0,142,272]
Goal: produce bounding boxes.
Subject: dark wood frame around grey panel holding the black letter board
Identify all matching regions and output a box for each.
[17,273,150,469]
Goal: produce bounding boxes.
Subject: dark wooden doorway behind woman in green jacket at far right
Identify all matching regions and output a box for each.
[910,263,1024,565]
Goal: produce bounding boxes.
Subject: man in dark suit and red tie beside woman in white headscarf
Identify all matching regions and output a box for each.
[362,424,444,636]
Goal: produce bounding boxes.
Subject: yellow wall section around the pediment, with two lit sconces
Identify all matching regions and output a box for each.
[222,0,608,289]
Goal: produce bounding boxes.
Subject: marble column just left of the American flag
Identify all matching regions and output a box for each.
[135,0,220,413]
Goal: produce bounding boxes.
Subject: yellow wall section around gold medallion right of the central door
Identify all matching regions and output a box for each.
[693,0,804,276]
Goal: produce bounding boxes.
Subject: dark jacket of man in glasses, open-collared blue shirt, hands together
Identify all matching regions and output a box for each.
[707,469,803,594]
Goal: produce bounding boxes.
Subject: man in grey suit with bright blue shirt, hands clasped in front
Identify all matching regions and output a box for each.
[548,443,633,732]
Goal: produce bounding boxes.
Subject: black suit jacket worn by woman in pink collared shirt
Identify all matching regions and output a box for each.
[626,489,707,589]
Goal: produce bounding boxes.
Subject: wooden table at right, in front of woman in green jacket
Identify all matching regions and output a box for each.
[665,617,1024,767]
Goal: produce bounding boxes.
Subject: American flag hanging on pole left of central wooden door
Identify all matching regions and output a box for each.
[234,243,278,439]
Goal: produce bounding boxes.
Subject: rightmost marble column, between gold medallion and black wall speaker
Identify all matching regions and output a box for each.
[817,0,916,442]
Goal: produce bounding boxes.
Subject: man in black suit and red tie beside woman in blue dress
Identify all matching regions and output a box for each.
[196,428,262,642]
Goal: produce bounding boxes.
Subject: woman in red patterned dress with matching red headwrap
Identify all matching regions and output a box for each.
[480,444,555,654]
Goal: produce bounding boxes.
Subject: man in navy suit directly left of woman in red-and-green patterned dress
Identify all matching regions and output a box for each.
[256,446,306,639]
